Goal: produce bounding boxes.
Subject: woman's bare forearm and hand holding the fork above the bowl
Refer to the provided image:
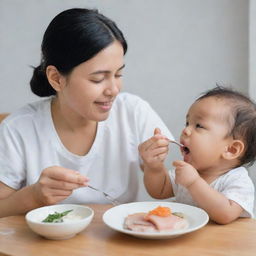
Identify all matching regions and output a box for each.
[0,166,88,217]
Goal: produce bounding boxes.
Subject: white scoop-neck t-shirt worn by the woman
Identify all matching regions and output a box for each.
[0,93,172,203]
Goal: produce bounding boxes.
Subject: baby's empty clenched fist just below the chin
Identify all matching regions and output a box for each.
[173,161,200,188]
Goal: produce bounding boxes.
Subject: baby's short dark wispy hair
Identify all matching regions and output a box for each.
[197,86,256,166]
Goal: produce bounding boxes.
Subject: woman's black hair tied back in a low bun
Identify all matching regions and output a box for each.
[30,8,127,97]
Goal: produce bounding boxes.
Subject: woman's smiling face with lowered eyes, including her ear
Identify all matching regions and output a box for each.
[58,41,124,121]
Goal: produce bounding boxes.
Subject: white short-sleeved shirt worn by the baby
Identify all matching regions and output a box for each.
[169,167,254,217]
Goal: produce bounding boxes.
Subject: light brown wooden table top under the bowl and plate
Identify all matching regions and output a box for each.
[0,204,256,256]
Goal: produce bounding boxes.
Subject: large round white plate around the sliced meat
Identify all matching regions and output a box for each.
[103,201,209,239]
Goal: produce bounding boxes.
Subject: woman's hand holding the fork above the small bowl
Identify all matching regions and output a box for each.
[33,166,89,205]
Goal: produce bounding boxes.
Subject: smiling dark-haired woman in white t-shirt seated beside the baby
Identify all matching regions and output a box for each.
[0,9,171,217]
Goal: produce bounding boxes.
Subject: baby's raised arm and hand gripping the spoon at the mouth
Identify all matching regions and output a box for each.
[139,129,173,199]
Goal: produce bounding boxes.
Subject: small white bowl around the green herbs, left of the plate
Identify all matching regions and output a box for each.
[25,204,94,240]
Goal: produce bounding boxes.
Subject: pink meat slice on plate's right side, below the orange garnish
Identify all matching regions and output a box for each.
[144,214,188,231]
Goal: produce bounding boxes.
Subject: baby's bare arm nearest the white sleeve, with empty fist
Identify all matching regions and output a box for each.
[173,161,243,224]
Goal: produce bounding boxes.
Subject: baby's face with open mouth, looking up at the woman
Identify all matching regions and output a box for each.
[180,97,231,171]
